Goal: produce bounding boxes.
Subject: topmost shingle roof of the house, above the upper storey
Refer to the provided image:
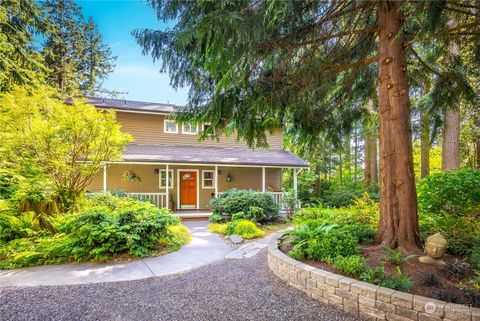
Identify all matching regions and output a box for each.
[67,97,180,113]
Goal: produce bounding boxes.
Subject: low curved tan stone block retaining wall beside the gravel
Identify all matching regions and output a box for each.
[267,235,480,321]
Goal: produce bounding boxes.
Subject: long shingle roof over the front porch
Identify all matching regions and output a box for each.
[122,144,308,167]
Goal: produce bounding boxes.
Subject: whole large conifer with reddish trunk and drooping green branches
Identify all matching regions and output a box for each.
[133,0,479,251]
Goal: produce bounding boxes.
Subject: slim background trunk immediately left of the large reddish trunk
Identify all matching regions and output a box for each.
[364,99,378,191]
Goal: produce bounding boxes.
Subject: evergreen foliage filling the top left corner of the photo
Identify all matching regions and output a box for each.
[0,0,48,92]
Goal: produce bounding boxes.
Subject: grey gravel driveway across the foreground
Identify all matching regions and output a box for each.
[0,250,358,321]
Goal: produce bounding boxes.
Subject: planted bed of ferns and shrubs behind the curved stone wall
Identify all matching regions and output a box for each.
[280,171,480,307]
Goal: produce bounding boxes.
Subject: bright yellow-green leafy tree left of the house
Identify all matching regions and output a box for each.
[0,87,131,210]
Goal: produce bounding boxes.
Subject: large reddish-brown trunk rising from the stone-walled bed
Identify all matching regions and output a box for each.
[376,1,420,252]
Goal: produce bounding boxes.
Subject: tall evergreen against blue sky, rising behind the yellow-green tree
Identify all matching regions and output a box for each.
[43,0,116,95]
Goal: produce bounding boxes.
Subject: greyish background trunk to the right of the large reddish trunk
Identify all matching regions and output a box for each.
[442,108,460,171]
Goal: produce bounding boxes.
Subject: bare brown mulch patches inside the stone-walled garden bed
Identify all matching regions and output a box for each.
[279,239,480,307]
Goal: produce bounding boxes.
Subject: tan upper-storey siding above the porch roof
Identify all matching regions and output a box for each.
[117,112,283,149]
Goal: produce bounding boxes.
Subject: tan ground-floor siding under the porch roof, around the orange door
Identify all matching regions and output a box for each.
[87,164,282,209]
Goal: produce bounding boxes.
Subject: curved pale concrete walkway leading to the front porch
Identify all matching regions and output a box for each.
[0,221,232,288]
